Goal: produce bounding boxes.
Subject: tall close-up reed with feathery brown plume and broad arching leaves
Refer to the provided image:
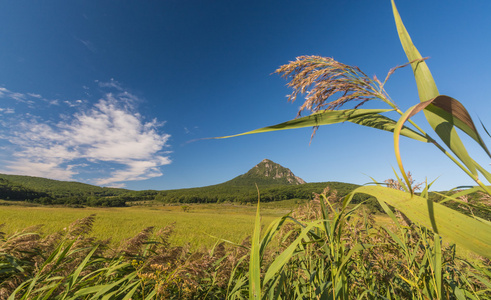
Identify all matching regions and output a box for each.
[220,1,491,258]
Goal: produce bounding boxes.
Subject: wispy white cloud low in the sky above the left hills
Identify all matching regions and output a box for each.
[0,80,171,186]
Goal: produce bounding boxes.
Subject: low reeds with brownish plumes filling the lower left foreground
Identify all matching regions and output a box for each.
[0,215,247,300]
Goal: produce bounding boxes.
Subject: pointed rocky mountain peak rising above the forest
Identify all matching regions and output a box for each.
[222,159,305,186]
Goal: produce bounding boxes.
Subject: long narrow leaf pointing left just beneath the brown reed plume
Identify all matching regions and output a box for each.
[215,109,428,142]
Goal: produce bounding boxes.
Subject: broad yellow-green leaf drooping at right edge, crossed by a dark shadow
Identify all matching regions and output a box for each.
[353,186,491,258]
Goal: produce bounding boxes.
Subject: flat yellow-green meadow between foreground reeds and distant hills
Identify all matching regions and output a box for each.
[0,200,295,249]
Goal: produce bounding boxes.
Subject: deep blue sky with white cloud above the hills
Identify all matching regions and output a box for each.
[0,0,491,190]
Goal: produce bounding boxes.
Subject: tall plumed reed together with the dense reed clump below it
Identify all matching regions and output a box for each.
[216,1,491,299]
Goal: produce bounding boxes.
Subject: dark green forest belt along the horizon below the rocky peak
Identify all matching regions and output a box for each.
[0,174,491,220]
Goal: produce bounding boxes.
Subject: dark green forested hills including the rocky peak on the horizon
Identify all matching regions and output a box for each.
[0,159,368,206]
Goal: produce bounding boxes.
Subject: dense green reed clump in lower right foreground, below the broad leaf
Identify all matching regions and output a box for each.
[229,190,491,299]
